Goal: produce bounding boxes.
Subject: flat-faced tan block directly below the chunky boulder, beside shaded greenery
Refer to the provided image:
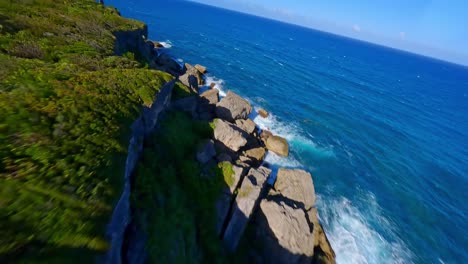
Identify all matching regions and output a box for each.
[214,119,248,151]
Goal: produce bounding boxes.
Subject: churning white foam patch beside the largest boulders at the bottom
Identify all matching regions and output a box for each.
[317,194,412,263]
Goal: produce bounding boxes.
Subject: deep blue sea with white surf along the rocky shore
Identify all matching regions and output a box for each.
[106,0,468,263]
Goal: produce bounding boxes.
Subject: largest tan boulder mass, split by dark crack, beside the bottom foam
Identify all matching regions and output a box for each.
[250,169,335,263]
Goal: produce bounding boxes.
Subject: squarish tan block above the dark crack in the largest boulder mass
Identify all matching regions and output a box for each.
[275,168,315,210]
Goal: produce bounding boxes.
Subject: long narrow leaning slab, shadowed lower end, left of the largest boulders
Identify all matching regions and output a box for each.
[223,166,271,251]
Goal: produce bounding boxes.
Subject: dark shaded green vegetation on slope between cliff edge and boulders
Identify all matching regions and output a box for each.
[132,112,233,263]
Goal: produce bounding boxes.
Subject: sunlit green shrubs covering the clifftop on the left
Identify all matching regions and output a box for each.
[0,0,172,263]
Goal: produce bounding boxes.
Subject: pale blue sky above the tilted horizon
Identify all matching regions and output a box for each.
[188,0,468,65]
